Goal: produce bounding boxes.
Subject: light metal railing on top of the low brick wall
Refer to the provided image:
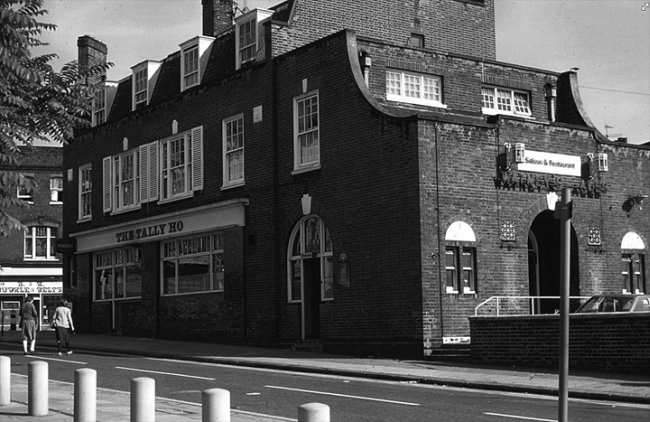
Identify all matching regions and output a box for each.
[474,296,590,316]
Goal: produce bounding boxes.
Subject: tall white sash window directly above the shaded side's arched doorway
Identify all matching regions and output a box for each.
[293,91,320,170]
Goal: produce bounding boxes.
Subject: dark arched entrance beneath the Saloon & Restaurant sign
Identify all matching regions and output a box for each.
[528,210,580,314]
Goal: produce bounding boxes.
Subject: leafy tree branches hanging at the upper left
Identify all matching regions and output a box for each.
[0,0,110,236]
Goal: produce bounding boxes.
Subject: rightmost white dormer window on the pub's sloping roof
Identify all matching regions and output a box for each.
[235,9,273,69]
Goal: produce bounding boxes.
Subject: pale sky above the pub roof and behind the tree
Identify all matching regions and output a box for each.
[38,0,650,144]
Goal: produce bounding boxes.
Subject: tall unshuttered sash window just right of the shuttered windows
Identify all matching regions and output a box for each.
[223,114,244,187]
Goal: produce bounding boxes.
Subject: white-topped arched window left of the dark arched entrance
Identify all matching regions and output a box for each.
[445,221,476,294]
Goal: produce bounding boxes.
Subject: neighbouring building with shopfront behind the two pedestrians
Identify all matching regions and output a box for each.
[0,142,63,330]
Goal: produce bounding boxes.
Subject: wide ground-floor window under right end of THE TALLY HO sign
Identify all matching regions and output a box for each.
[161,233,225,296]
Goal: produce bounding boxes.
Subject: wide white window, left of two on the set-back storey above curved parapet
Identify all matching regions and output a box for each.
[386,69,446,107]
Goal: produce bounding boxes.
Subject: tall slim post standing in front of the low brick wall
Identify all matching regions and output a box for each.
[555,188,573,422]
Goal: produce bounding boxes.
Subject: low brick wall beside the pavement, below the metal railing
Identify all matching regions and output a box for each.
[470,313,650,371]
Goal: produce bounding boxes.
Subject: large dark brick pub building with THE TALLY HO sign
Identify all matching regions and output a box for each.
[59,0,650,356]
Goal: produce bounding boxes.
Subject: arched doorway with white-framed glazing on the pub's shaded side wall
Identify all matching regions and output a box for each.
[287,215,334,339]
